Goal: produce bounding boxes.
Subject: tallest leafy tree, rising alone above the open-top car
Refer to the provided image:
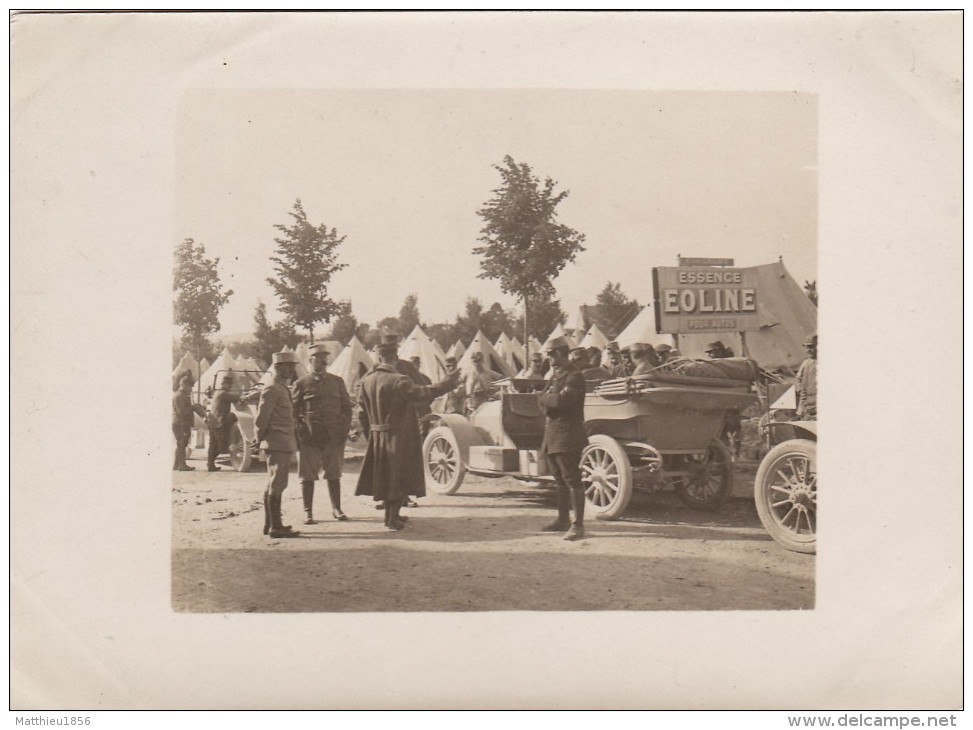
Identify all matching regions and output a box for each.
[473,155,585,356]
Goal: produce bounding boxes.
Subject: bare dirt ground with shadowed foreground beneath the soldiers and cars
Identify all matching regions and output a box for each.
[172,440,815,613]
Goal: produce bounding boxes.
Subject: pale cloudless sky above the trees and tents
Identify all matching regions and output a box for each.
[175,89,818,333]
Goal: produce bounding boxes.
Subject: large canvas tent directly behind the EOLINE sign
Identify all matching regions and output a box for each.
[678,262,818,369]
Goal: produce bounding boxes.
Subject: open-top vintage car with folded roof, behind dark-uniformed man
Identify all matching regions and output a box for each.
[423,375,756,520]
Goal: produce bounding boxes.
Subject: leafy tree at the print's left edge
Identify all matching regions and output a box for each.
[172,238,233,378]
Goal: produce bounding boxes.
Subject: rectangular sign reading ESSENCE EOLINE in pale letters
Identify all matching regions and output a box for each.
[652,266,760,334]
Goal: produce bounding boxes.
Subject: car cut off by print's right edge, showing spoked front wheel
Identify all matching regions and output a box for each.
[753,420,818,553]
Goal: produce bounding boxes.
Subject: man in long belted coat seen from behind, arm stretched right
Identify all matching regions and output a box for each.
[355,336,459,530]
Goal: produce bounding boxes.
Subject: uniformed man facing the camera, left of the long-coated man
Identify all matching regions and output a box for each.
[291,345,351,525]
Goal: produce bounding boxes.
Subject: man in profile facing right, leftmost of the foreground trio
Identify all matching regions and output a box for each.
[254,352,301,538]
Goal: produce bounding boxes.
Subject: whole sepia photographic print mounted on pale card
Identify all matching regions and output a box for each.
[172,89,818,612]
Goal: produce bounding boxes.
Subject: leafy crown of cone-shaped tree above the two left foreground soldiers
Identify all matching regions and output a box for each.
[267,199,348,342]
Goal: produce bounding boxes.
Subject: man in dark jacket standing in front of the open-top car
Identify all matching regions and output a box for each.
[538,337,588,540]
